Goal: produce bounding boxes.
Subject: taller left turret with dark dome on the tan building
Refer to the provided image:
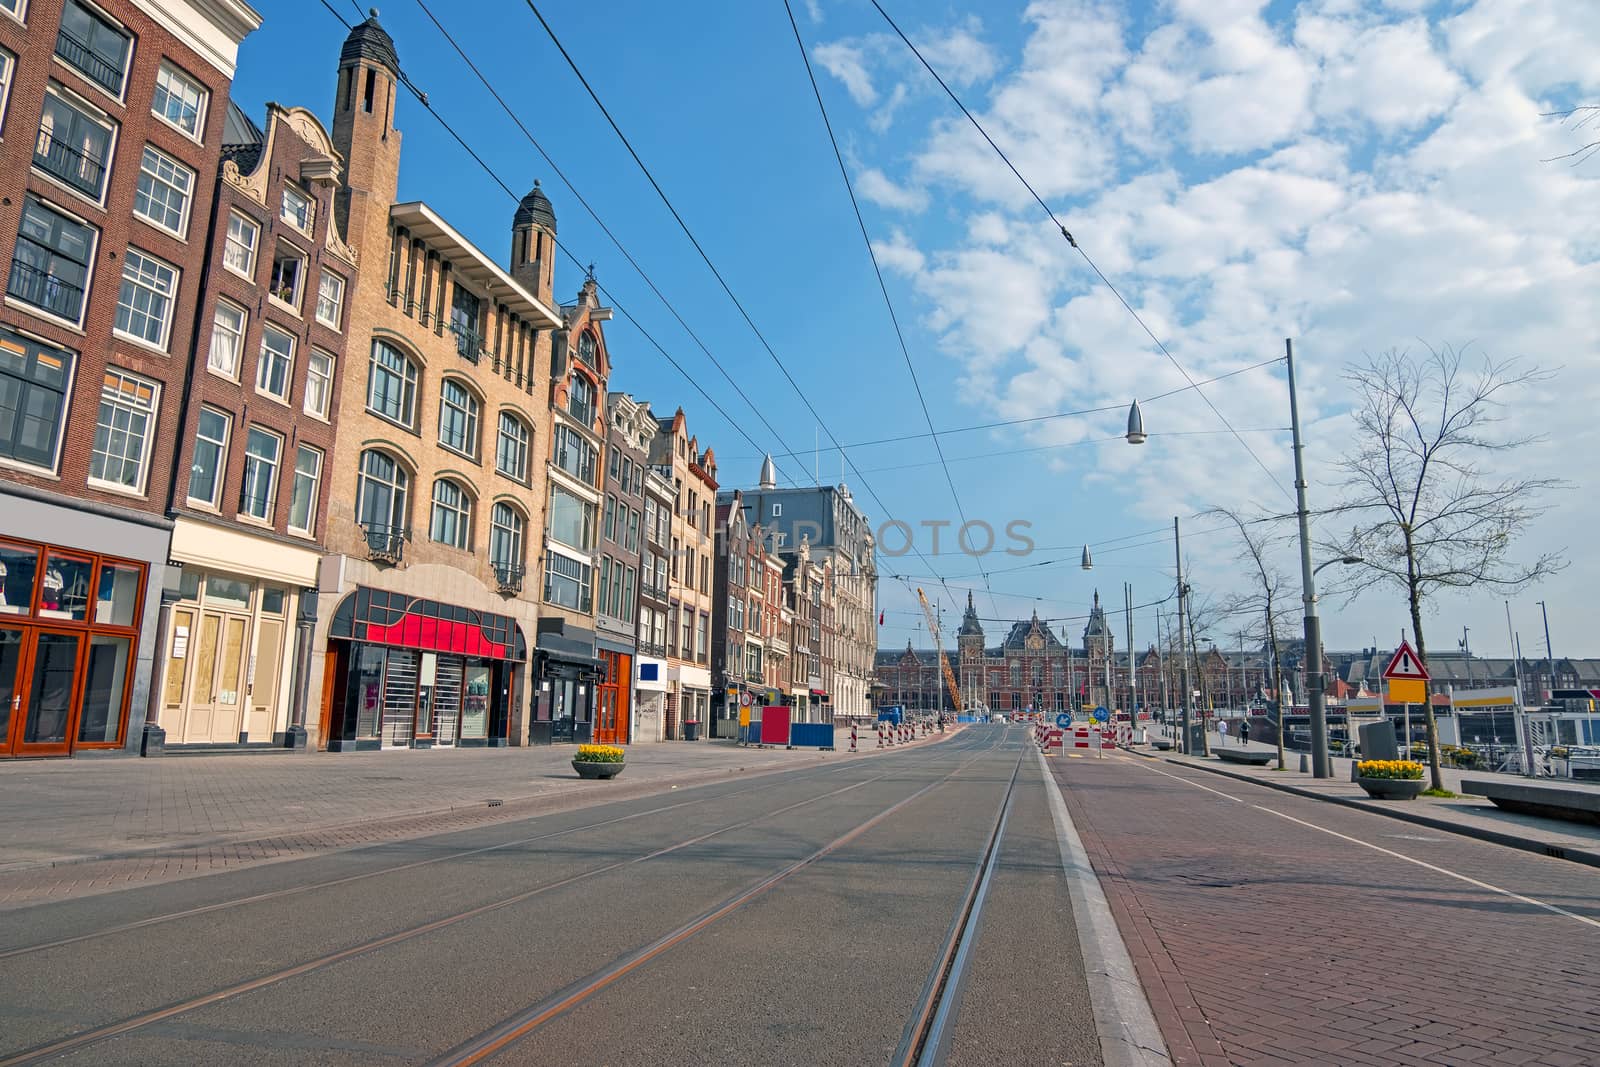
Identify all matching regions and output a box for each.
[333,8,400,262]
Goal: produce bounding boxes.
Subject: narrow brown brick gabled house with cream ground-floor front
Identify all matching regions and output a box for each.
[158,104,358,745]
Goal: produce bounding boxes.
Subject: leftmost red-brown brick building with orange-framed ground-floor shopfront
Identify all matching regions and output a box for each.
[0,0,261,757]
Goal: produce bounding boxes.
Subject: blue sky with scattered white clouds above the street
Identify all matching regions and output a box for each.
[234,0,1600,654]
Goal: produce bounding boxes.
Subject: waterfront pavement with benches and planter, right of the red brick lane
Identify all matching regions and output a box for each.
[1160,734,1600,867]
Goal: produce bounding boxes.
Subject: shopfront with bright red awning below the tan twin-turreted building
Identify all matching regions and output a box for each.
[322,585,528,752]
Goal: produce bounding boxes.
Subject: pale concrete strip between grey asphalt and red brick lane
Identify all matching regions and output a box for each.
[1034,749,1173,1067]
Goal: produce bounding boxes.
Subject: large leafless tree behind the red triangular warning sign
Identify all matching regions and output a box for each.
[1307,347,1565,789]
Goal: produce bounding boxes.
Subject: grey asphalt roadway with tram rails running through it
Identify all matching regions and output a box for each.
[0,726,1101,1067]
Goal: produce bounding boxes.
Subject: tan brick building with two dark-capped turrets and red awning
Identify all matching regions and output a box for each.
[309,16,563,750]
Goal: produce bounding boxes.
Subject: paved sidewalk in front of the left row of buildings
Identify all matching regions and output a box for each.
[0,729,955,910]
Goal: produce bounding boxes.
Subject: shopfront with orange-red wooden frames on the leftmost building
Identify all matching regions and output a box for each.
[0,539,150,757]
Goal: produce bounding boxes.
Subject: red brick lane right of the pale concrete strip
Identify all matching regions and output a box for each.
[1054,757,1600,1067]
